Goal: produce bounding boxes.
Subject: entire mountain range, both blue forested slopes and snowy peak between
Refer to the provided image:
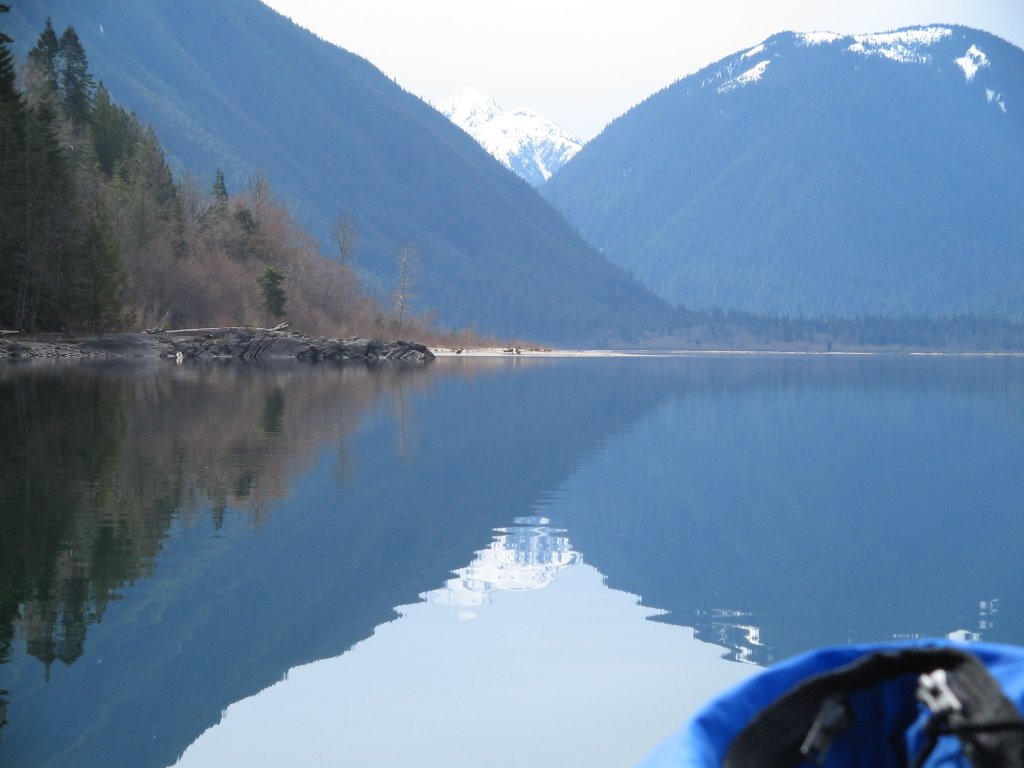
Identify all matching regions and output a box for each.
[4,0,1024,345]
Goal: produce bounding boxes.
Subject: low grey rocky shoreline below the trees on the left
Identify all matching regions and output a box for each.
[0,327,434,366]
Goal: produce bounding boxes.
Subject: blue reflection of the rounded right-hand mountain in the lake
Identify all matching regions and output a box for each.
[542,358,1024,664]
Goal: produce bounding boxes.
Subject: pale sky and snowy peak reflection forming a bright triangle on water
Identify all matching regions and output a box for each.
[176,516,751,768]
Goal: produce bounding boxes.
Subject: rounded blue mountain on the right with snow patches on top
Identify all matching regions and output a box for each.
[543,26,1024,319]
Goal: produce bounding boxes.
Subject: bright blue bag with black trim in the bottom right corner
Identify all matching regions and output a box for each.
[641,640,1024,768]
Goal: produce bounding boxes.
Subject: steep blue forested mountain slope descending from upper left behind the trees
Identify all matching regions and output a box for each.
[5,0,667,342]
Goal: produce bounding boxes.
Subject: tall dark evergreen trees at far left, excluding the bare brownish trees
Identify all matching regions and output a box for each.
[0,12,128,331]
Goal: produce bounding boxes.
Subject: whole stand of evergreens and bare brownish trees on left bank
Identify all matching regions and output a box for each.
[0,6,456,342]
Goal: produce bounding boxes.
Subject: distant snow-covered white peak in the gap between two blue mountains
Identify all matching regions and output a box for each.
[437,88,583,186]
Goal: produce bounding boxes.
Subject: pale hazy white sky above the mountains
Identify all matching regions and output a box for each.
[264,0,1024,139]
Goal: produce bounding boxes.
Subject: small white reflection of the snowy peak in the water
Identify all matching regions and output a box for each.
[436,515,581,618]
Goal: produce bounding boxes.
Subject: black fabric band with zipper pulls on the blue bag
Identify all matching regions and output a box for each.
[723,648,1024,768]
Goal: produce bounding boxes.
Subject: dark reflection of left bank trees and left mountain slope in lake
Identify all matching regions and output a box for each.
[0,358,679,766]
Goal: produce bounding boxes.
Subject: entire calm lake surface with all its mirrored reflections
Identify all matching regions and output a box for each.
[0,355,1024,768]
